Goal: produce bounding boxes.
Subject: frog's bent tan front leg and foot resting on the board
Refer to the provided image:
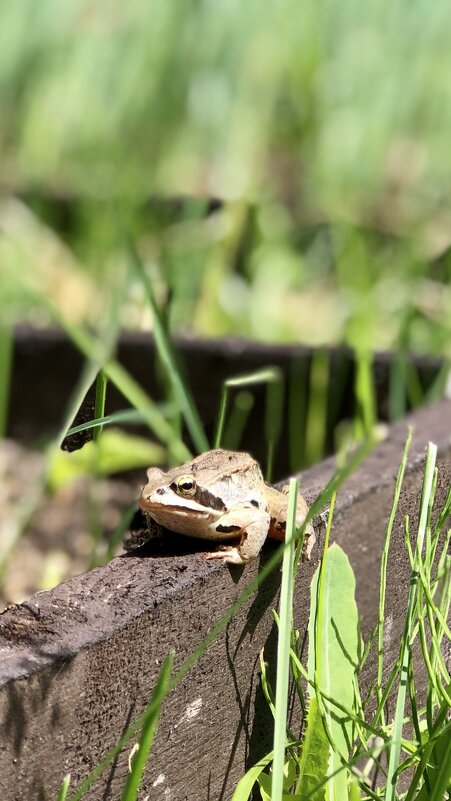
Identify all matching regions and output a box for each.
[205,503,270,565]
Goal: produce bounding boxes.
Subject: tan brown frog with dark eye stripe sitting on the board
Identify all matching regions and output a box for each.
[139,448,315,565]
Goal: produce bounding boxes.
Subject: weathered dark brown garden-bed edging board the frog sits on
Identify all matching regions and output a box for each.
[0,401,451,801]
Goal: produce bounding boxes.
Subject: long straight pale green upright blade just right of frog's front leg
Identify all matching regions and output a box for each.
[271,478,298,801]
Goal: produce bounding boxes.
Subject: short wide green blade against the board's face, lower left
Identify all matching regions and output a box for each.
[121,654,173,801]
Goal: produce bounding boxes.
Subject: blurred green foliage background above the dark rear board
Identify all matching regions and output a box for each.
[0,0,451,356]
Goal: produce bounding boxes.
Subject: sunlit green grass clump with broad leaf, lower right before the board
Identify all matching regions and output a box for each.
[233,438,451,801]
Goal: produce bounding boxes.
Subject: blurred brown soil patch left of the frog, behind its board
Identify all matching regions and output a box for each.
[0,440,140,610]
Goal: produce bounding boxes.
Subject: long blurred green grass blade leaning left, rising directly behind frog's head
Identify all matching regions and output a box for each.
[129,243,210,452]
